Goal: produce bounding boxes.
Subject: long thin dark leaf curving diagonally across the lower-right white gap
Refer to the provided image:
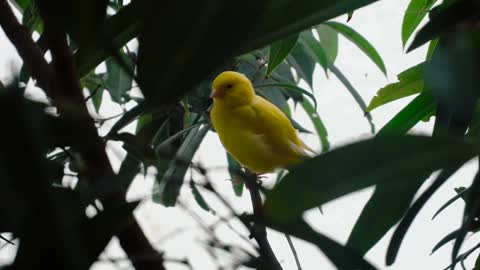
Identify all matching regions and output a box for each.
[386,165,461,265]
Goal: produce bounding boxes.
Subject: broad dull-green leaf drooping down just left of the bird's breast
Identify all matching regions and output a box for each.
[158,124,210,206]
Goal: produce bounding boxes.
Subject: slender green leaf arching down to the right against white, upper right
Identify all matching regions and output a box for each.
[323,21,387,75]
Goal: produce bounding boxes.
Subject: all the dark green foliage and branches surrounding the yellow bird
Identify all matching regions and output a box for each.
[0,0,480,270]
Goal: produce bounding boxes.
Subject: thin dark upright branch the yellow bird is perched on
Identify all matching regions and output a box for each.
[245,174,282,270]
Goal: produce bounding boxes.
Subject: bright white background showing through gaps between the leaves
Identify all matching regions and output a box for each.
[0,0,478,270]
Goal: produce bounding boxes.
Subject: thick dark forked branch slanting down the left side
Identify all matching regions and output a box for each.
[0,0,164,270]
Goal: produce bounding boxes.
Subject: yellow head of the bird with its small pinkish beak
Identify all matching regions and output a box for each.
[210,71,255,107]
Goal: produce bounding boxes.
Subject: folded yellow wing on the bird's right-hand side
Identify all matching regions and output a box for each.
[251,96,311,156]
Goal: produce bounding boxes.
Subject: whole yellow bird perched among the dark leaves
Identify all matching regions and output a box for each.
[210,71,314,174]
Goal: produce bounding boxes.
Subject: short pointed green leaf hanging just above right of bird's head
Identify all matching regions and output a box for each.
[287,41,315,88]
